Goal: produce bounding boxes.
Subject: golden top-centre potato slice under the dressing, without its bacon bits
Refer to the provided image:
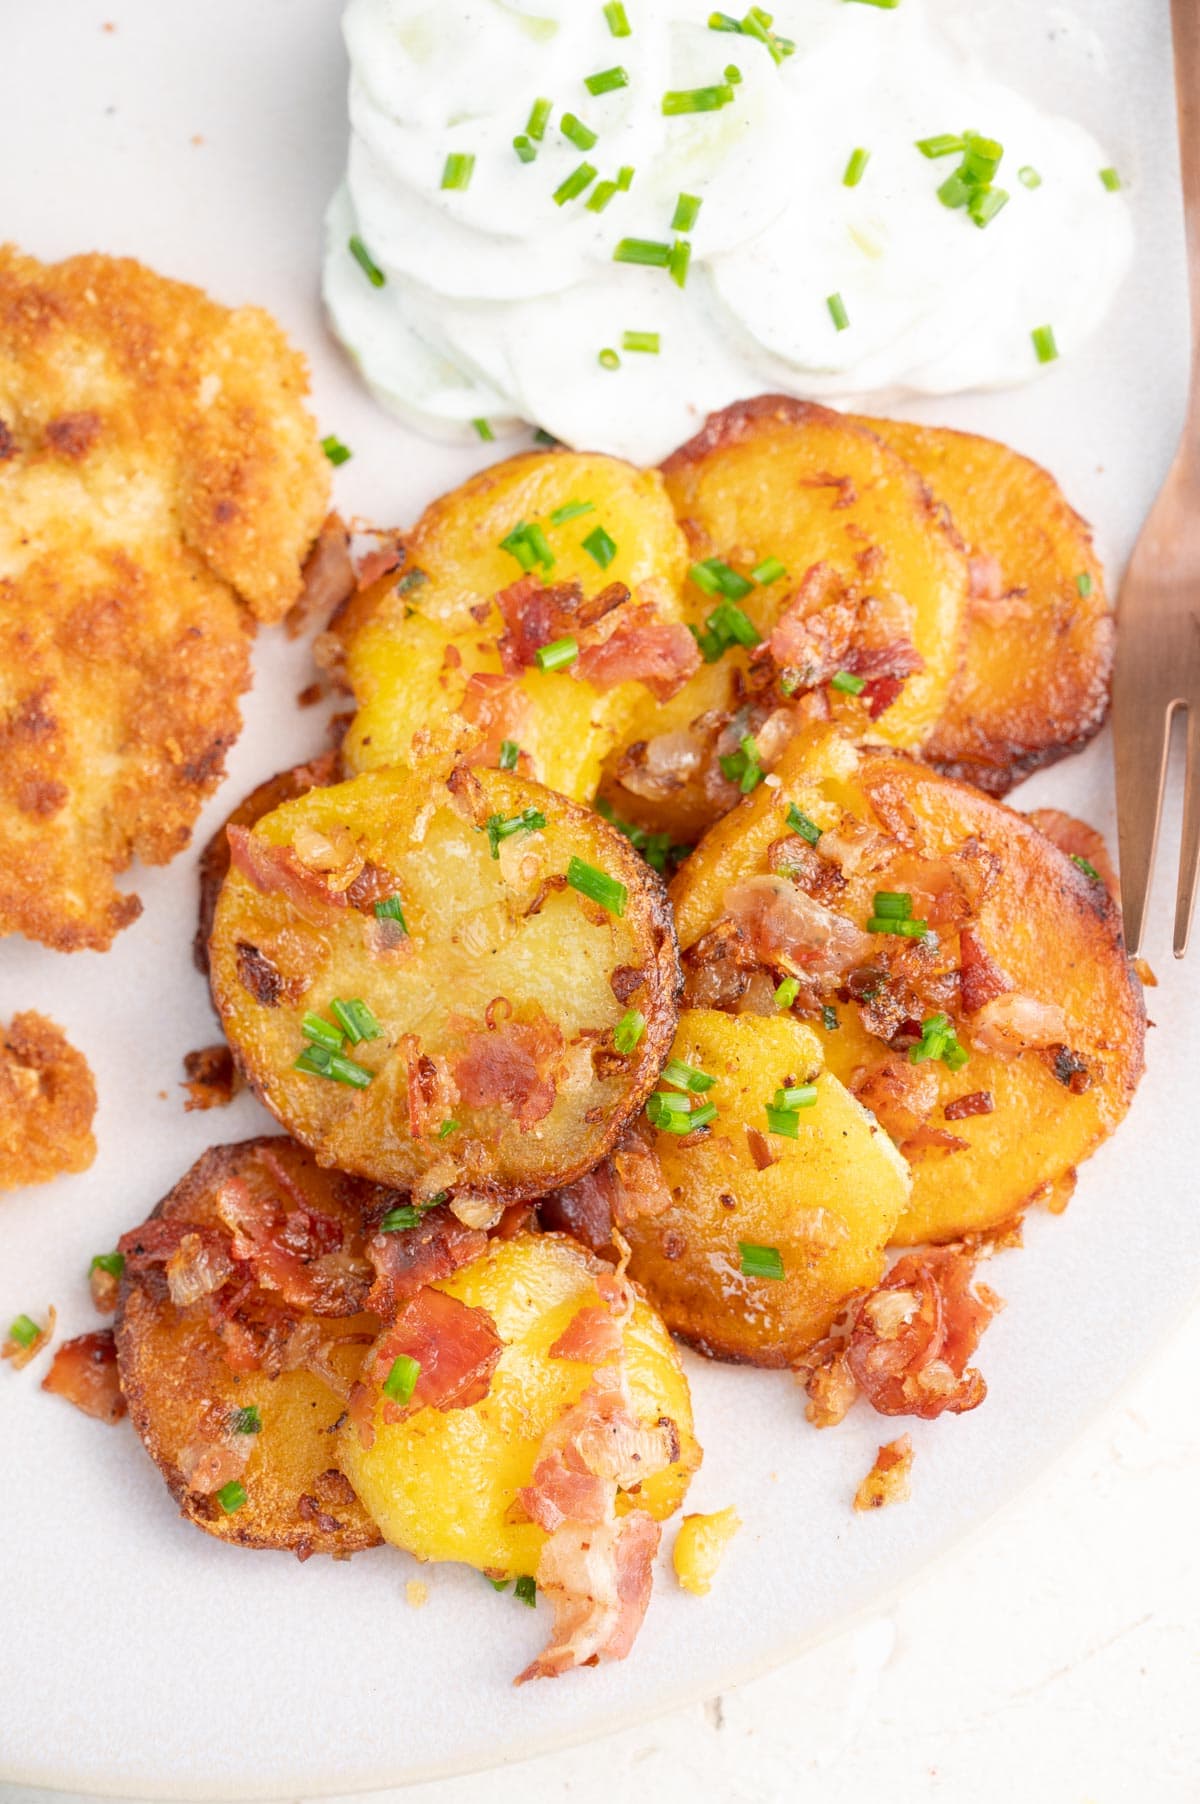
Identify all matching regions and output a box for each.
[603,395,967,844]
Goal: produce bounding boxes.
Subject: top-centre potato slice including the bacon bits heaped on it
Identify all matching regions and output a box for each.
[603,395,967,844]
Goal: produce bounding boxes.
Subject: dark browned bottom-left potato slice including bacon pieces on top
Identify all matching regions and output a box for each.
[115,1137,381,1557]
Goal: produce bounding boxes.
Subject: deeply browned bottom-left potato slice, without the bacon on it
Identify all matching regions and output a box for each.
[115,1137,379,1555]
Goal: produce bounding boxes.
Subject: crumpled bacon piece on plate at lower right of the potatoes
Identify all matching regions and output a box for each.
[846,1247,1002,1418]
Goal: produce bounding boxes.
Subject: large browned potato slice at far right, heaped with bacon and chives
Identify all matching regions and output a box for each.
[671,729,1144,1243]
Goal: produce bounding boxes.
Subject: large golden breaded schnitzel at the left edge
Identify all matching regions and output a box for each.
[0,247,328,951]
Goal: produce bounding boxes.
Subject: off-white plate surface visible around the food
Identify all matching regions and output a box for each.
[0,0,1200,1799]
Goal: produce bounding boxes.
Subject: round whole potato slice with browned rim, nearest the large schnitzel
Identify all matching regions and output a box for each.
[211,767,678,1201]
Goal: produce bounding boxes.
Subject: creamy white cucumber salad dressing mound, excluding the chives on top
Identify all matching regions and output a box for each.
[325,0,1133,462]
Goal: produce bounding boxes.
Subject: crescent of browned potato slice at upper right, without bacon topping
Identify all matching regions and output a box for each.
[861,419,1113,796]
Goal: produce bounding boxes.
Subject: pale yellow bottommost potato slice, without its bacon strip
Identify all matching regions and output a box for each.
[339,1234,700,1575]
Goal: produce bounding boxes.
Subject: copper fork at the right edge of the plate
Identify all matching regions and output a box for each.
[1113,0,1200,958]
